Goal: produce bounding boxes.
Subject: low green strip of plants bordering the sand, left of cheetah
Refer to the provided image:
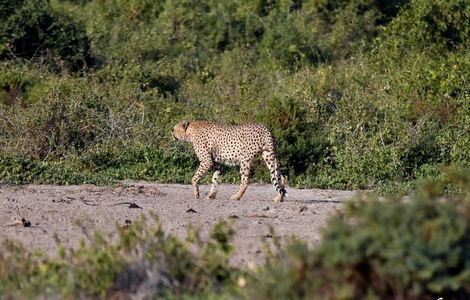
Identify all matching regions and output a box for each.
[0,145,200,185]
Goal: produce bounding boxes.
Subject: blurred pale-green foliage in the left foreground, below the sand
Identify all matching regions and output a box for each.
[0,216,237,299]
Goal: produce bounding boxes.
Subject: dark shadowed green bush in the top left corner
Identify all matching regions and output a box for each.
[0,0,91,71]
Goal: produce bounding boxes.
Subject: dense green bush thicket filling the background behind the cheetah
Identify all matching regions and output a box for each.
[0,0,470,188]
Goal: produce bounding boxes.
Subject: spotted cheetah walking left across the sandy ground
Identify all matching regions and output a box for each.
[173,121,286,202]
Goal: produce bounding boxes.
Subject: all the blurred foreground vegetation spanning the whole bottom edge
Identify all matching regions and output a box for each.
[0,171,470,299]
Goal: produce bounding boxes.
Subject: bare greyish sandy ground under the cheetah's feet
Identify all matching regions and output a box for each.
[0,182,354,264]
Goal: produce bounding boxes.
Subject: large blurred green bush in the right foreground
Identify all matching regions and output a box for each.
[247,170,470,299]
